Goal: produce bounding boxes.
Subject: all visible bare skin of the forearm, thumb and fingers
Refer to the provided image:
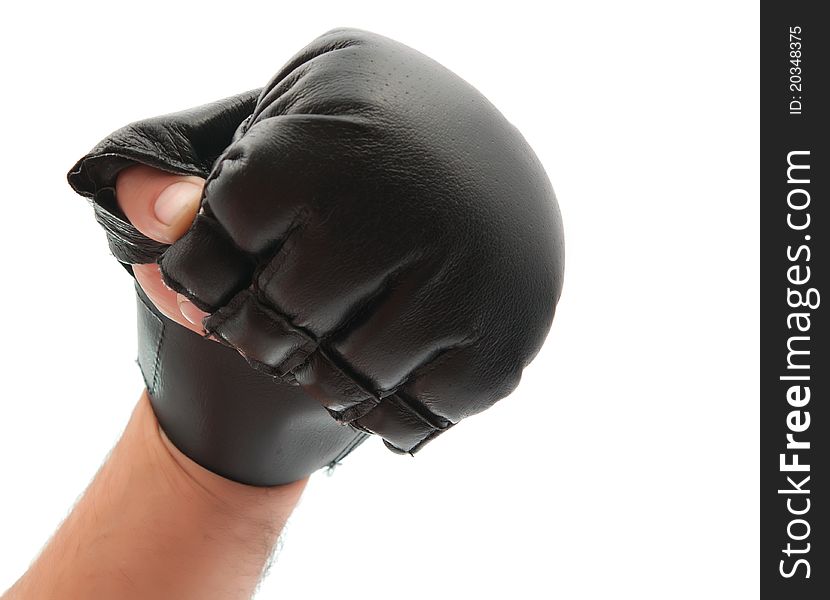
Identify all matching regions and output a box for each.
[2,165,308,600]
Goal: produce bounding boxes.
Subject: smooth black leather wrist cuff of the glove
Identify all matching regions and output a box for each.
[136,284,368,485]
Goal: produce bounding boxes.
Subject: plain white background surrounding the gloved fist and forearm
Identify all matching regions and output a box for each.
[0,0,759,600]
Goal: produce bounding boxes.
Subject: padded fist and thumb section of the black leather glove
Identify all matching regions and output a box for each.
[69,29,564,478]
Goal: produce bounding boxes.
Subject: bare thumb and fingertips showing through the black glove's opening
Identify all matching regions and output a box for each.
[115,165,208,334]
